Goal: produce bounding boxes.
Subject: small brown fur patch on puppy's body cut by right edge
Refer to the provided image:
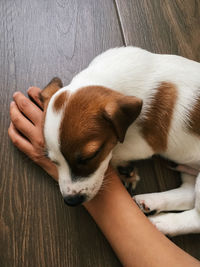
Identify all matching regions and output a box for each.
[189,96,200,135]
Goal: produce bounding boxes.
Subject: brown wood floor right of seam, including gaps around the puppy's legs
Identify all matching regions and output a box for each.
[115,0,200,259]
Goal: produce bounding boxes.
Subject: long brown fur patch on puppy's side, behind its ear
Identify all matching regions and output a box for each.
[139,82,177,153]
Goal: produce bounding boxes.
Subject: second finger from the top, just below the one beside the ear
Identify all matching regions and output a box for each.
[13,92,43,125]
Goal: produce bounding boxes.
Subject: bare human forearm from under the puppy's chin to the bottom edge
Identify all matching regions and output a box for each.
[85,169,200,267]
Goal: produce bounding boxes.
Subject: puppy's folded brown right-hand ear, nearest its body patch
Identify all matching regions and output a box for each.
[103,96,142,143]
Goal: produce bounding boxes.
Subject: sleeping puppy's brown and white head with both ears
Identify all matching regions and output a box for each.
[41,78,142,206]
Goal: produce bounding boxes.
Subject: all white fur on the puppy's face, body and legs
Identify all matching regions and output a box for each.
[45,47,200,235]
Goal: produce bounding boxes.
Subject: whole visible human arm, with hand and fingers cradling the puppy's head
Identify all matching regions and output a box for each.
[8,88,200,267]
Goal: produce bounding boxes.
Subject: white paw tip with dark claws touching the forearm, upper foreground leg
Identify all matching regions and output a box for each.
[133,194,159,215]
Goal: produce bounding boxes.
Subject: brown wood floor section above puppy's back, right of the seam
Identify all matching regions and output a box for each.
[115,0,200,61]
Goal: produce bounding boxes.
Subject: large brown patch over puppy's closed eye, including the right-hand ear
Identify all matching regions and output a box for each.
[60,86,142,177]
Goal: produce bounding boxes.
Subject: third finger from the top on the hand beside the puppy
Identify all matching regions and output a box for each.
[10,101,35,141]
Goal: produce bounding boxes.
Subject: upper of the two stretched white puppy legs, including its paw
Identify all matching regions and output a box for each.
[134,173,196,214]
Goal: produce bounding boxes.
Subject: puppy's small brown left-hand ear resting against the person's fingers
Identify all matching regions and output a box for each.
[40,77,63,108]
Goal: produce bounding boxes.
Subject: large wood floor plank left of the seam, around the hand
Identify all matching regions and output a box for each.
[0,0,123,267]
